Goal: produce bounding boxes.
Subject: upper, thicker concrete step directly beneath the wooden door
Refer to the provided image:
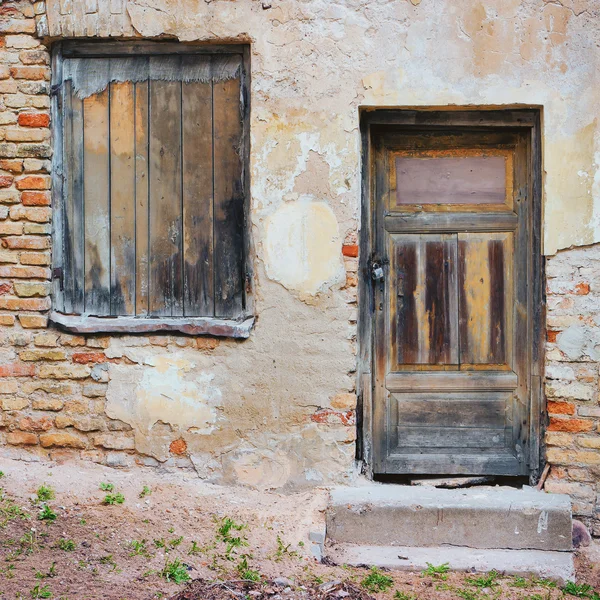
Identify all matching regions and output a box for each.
[327,483,572,551]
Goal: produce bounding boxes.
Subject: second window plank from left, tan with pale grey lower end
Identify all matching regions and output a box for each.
[83,60,110,316]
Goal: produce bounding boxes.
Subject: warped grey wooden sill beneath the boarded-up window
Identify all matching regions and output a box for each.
[49,311,254,339]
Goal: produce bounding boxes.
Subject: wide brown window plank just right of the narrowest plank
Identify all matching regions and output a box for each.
[149,56,183,316]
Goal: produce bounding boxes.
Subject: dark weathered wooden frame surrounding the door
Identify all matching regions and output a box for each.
[357,107,547,483]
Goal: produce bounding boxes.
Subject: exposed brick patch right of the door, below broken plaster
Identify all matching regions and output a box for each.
[546,245,600,535]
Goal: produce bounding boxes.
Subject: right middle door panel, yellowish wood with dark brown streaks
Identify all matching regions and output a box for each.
[458,233,513,369]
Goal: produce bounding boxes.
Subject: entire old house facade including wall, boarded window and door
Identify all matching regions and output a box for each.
[0,0,600,535]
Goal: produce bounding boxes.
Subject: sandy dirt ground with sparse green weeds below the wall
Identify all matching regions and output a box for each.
[0,460,600,600]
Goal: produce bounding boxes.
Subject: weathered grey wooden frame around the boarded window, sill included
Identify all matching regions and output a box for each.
[49,40,255,338]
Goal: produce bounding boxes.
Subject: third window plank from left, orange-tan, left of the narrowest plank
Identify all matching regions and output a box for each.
[110,81,135,315]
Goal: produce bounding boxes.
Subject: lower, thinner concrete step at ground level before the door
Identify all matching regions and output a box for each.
[327,544,575,584]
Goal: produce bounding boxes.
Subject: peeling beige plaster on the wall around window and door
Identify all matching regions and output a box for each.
[1,0,600,487]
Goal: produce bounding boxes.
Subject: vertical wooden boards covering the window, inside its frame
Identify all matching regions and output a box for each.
[50,51,247,332]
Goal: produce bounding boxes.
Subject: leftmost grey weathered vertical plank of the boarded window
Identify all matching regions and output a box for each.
[60,80,85,314]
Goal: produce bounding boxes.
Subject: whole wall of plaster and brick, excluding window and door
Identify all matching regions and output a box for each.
[0,0,600,519]
